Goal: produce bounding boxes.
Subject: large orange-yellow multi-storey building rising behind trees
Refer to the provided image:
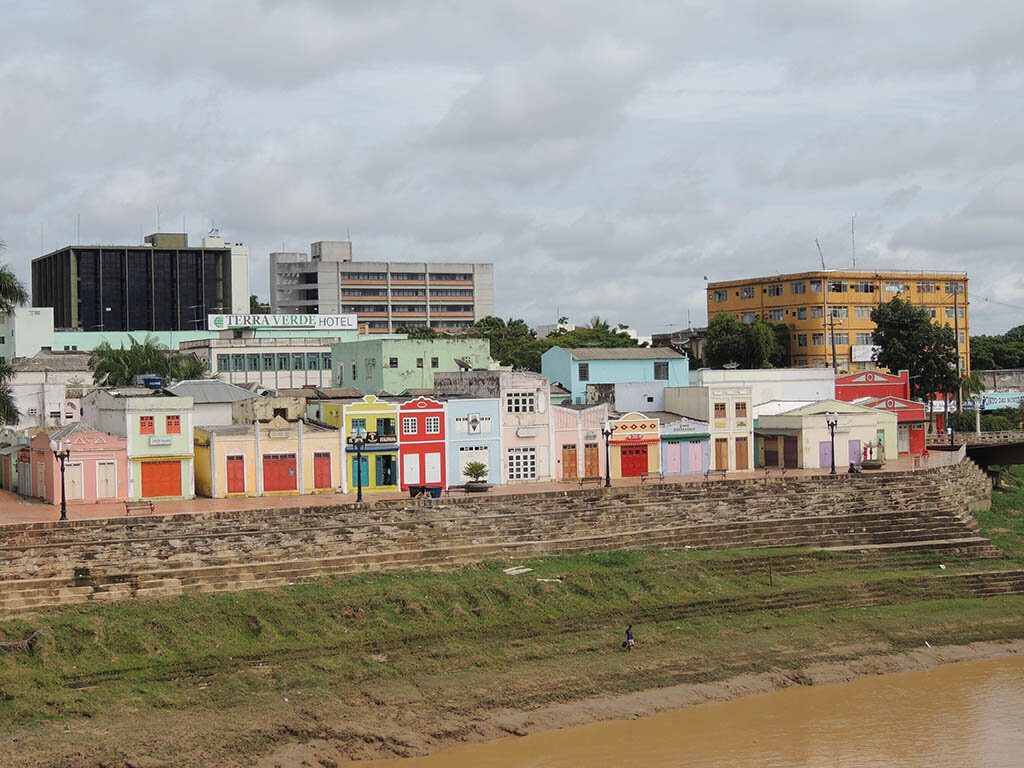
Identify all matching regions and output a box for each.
[708,269,971,374]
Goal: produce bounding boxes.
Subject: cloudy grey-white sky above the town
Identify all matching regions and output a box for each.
[0,0,1024,333]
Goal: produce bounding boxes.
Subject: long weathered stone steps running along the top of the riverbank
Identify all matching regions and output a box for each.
[0,462,999,614]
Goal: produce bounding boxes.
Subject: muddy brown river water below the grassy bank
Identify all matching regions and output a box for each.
[357,655,1024,768]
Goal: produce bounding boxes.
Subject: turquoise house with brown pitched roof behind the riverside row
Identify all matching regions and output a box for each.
[541,347,690,403]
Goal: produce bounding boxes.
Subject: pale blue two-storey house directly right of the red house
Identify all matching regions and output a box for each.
[445,397,502,485]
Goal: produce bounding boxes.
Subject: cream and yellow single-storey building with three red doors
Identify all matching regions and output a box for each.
[195,417,345,499]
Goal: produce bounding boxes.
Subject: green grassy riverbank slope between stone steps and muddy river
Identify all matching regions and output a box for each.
[0,479,1024,765]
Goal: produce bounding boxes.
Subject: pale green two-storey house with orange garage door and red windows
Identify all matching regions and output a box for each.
[82,388,196,501]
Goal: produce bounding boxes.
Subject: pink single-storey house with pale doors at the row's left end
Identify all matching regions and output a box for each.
[30,422,128,505]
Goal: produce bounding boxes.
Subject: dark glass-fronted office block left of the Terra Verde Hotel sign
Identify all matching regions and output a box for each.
[32,233,239,331]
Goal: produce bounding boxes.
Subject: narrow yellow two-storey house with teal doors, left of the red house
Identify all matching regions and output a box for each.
[343,394,399,493]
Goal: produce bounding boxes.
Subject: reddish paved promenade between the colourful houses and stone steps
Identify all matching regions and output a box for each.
[0,453,955,525]
